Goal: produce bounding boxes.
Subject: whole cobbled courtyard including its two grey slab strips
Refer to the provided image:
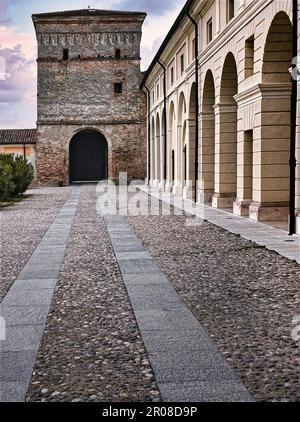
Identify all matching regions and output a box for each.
[0,185,300,402]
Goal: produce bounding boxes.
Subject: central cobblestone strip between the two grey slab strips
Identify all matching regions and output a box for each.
[27,186,159,402]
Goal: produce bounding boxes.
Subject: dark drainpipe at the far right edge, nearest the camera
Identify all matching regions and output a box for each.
[289,0,298,236]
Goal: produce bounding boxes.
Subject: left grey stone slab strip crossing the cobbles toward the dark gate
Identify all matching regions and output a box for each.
[0,187,81,402]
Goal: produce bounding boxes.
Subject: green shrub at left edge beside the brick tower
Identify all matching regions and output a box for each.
[0,154,34,201]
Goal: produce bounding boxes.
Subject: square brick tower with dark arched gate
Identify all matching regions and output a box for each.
[32,9,146,185]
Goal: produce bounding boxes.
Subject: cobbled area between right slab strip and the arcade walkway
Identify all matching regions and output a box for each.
[128,191,300,401]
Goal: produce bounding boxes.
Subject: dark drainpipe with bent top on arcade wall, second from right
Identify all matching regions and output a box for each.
[186,11,199,202]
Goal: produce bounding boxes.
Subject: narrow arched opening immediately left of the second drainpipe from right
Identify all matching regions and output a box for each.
[175,92,186,193]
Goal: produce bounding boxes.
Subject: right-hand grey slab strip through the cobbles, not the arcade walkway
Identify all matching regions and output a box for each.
[104,216,253,402]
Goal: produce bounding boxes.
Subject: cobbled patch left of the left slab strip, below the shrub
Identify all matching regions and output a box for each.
[0,188,70,301]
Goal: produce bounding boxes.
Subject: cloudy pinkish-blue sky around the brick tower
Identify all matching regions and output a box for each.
[0,0,185,129]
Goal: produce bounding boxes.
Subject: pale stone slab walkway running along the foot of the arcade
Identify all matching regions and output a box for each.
[138,185,300,264]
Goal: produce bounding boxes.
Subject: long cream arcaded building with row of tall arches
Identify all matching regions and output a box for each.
[143,0,300,233]
